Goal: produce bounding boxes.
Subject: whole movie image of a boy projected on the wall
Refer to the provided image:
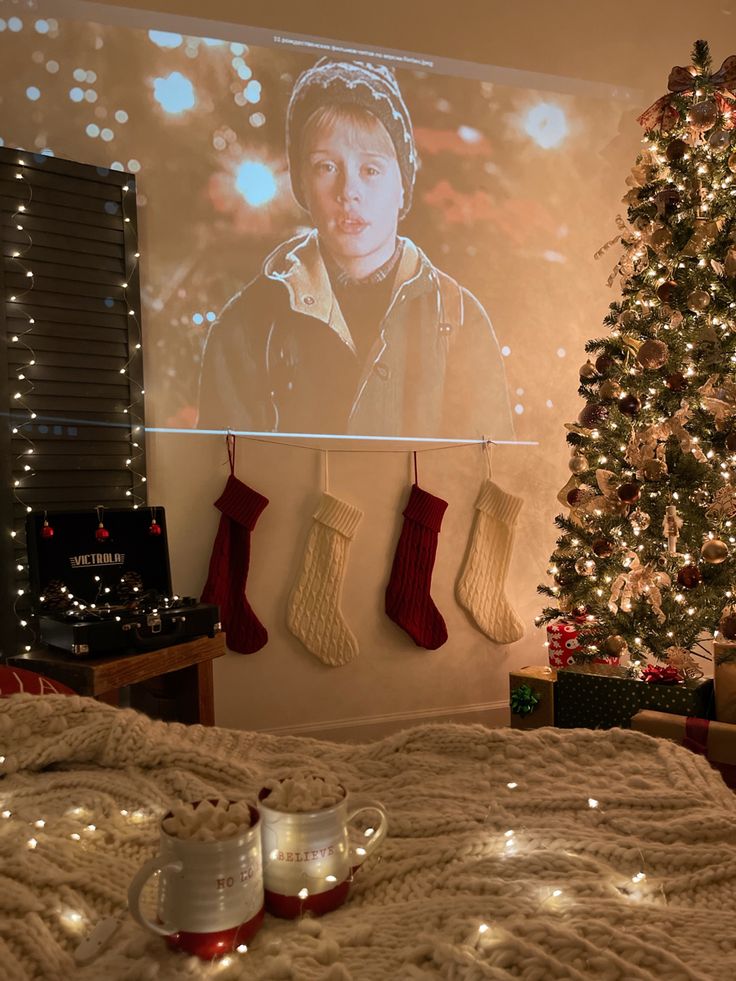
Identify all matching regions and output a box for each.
[0,11,622,440]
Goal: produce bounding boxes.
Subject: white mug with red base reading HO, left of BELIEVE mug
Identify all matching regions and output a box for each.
[128,801,263,959]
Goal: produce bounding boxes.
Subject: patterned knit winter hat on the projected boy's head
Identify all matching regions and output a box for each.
[286,58,417,218]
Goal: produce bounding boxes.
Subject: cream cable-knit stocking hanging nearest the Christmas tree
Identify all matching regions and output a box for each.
[456,480,524,644]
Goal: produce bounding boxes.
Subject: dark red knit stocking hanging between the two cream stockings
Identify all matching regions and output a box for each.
[386,484,447,651]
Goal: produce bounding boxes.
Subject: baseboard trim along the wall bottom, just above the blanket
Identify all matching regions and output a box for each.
[260,701,509,742]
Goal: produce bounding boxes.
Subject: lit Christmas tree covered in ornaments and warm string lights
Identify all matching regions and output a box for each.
[537,41,736,676]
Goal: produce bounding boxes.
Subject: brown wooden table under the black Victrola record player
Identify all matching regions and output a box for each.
[8,633,225,726]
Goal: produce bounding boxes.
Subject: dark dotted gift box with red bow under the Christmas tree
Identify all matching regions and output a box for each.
[555,668,714,729]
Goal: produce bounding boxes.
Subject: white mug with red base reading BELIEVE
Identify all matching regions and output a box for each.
[258,787,388,918]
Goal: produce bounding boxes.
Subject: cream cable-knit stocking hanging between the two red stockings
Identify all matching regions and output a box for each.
[286,494,363,667]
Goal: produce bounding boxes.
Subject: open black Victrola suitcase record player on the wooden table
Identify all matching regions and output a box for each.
[26,507,220,656]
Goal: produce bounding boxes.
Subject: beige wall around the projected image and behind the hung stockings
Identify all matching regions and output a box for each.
[7,0,736,738]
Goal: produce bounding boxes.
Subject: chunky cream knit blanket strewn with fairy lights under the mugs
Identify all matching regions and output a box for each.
[0,695,736,981]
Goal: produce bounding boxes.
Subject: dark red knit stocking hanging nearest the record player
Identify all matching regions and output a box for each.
[202,443,268,654]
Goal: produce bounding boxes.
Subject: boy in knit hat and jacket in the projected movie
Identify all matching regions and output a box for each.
[198,60,513,439]
